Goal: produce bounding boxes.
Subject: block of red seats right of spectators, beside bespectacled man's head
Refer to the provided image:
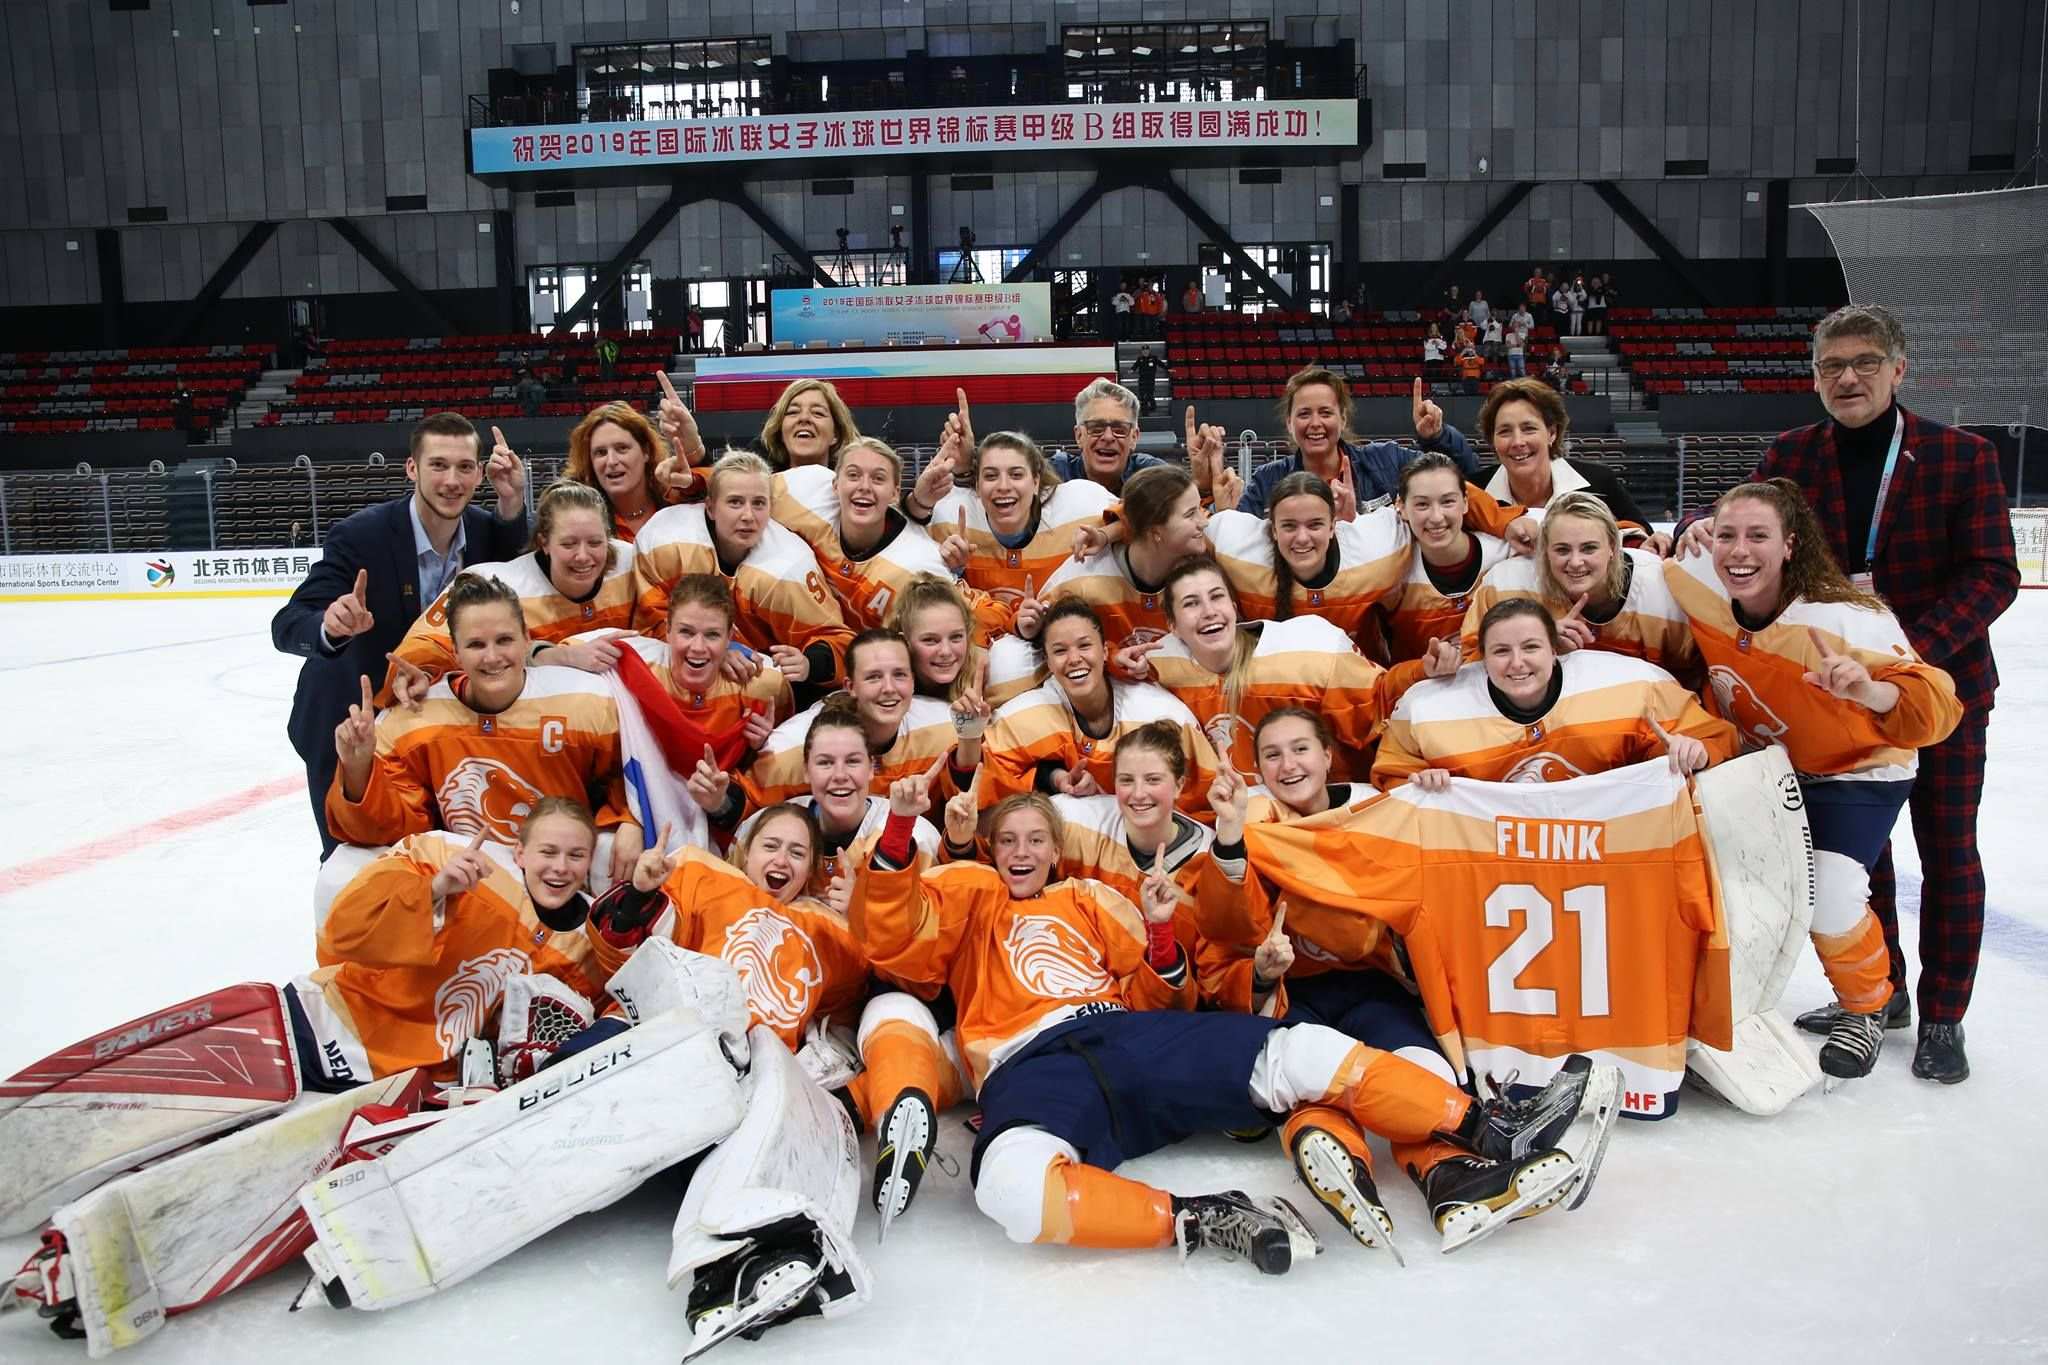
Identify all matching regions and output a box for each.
[1608,307,1827,395]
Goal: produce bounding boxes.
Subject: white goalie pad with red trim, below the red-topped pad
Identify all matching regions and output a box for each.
[53,1070,426,1357]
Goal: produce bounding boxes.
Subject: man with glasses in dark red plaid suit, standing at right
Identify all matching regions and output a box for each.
[1677,305,2019,1085]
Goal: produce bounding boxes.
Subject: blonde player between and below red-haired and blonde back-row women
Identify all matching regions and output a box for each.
[633,450,854,698]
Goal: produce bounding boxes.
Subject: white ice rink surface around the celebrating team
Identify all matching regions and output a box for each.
[0,591,2048,1365]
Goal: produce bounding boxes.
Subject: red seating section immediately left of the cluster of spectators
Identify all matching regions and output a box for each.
[1165,313,1587,399]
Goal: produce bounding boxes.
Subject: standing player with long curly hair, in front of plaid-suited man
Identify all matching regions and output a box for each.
[1663,479,1962,1076]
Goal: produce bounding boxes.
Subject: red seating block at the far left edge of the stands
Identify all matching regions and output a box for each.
[0,342,272,436]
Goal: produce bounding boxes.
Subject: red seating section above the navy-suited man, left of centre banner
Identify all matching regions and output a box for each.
[262,332,678,426]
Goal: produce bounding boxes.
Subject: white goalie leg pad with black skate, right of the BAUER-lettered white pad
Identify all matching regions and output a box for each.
[668,1027,872,1318]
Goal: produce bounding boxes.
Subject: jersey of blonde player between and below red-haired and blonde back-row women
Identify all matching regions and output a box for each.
[633,505,854,671]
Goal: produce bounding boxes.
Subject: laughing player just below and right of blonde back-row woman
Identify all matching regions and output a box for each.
[774,436,1012,645]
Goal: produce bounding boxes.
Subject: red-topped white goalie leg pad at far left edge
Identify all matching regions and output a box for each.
[0,982,299,1236]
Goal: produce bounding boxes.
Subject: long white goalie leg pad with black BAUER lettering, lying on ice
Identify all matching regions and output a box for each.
[299,1011,743,1308]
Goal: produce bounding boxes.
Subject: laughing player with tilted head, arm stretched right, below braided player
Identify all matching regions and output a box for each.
[1147,557,1458,772]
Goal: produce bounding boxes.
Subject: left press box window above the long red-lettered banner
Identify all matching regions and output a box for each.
[575,35,770,123]
